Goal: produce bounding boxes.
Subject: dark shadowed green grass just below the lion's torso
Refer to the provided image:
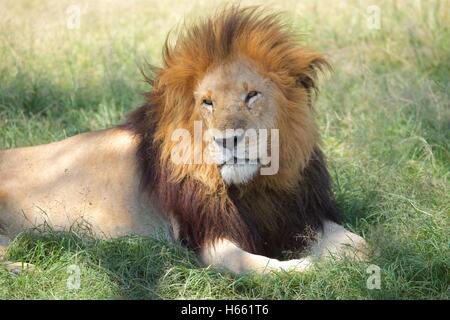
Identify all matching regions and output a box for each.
[7,226,199,299]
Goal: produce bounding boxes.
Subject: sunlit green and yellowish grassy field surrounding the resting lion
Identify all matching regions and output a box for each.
[0,0,450,299]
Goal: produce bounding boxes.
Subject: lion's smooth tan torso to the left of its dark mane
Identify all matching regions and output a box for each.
[0,129,170,237]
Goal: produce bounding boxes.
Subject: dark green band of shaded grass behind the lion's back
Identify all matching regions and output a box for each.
[0,70,138,119]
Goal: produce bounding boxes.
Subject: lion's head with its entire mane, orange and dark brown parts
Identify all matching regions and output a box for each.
[125,7,337,253]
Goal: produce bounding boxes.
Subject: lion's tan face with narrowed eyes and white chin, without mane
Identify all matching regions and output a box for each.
[194,59,278,184]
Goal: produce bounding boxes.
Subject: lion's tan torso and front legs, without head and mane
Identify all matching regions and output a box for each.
[0,128,364,273]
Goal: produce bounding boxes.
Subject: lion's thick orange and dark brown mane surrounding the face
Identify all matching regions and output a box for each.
[126,7,340,257]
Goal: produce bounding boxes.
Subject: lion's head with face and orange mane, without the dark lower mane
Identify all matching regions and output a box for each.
[149,7,327,188]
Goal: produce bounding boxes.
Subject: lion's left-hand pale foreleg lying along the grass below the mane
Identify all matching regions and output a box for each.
[200,239,312,274]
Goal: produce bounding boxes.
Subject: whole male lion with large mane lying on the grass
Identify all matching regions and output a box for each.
[0,7,367,274]
